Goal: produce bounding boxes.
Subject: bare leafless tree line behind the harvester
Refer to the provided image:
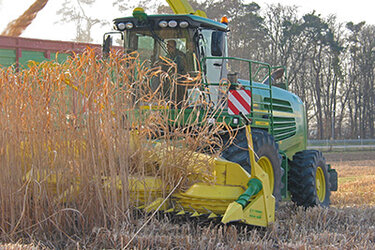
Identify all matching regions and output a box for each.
[60,0,375,139]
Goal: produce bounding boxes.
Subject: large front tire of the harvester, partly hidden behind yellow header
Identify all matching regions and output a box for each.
[221,129,284,207]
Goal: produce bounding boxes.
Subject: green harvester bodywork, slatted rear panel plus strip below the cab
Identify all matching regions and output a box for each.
[154,77,307,160]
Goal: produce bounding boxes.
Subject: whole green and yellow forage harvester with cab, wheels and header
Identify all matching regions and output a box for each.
[99,0,337,226]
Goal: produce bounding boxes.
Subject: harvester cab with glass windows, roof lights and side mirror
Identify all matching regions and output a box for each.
[103,8,232,103]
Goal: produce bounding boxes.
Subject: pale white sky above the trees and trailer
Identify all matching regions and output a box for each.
[0,0,375,43]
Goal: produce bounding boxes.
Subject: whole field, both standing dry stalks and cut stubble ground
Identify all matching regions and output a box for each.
[0,50,375,249]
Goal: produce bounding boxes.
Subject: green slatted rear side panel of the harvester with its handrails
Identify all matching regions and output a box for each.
[202,57,307,160]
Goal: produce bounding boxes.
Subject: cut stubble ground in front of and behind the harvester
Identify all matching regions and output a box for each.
[1,151,375,249]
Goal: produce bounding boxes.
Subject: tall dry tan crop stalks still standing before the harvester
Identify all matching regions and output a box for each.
[0,50,229,246]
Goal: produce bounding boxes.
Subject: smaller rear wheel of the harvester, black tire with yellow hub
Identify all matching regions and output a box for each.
[289,150,331,208]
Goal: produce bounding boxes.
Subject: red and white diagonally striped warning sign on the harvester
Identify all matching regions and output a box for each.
[228,89,251,115]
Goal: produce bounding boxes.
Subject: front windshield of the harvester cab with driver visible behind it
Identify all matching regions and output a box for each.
[125,28,197,74]
